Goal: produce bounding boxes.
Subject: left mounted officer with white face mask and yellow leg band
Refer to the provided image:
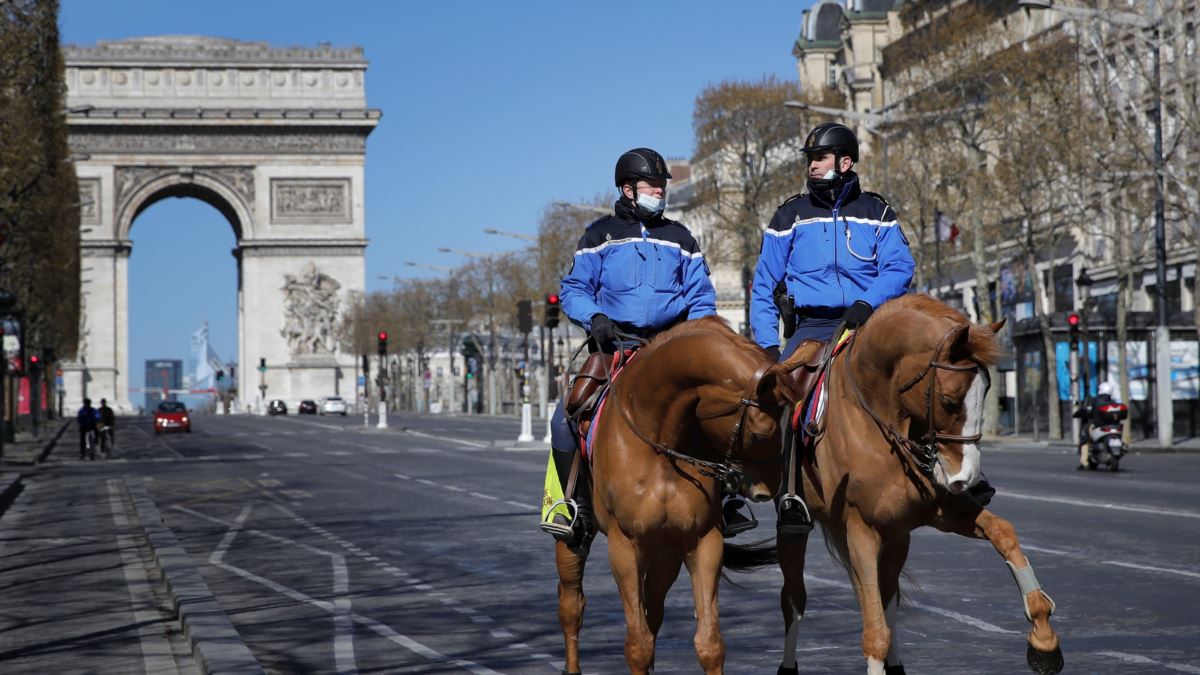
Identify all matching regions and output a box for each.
[542,148,716,546]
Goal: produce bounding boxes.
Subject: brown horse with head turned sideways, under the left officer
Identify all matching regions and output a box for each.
[554,317,798,674]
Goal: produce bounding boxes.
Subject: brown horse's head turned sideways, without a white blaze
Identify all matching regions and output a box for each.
[696,351,799,502]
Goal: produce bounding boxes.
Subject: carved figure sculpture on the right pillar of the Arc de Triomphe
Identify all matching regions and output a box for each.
[280,263,342,354]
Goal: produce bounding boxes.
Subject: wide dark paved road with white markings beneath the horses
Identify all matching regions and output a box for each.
[9,416,1200,674]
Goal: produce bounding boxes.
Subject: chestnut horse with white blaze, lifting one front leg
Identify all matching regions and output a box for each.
[776,294,1063,675]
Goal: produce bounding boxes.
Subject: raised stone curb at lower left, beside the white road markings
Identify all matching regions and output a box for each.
[121,478,264,675]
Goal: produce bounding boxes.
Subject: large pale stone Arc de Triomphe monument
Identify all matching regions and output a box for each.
[64,36,380,411]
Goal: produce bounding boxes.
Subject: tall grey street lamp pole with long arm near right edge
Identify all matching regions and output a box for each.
[1018,0,1175,446]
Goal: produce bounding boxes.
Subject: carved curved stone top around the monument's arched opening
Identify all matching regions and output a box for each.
[114,167,254,241]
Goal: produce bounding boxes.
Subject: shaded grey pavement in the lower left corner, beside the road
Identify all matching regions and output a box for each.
[0,424,253,675]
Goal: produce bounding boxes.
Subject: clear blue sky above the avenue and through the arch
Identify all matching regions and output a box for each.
[61,0,811,386]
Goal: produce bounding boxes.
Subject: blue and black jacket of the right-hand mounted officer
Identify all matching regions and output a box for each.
[750,172,916,347]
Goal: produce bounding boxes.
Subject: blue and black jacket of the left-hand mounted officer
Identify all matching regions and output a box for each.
[559,202,716,333]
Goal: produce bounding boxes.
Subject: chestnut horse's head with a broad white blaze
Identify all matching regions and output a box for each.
[895,315,1004,495]
